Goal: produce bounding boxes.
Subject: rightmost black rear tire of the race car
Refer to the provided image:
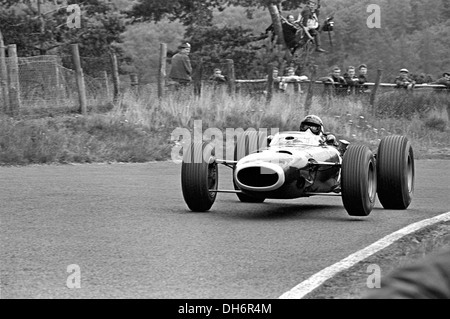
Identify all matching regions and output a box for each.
[377,135,415,210]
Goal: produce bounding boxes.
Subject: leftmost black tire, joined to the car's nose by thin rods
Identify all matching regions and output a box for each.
[181,142,219,212]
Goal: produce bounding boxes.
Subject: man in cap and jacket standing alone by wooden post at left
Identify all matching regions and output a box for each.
[169,43,192,88]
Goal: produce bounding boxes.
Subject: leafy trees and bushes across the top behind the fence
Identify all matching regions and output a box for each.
[0,0,450,83]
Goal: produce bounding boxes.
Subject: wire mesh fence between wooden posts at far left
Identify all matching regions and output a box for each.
[0,50,112,113]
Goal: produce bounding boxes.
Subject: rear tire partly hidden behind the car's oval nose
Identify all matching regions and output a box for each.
[233,131,267,203]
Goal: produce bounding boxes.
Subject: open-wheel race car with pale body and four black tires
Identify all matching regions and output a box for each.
[181,131,415,217]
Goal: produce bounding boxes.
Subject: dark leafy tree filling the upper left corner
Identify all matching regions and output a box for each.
[0,0,125,56]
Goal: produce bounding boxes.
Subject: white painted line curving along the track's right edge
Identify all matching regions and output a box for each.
[279,212,450,299]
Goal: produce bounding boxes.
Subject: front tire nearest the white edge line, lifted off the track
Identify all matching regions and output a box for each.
[341,145,377,217]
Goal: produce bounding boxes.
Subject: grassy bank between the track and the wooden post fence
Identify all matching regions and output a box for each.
[0,86,450,165]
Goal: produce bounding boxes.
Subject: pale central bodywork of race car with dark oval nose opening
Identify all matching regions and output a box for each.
[234,132,342,199]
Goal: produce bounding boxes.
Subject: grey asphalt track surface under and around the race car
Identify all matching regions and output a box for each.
[0,160,450,299]
